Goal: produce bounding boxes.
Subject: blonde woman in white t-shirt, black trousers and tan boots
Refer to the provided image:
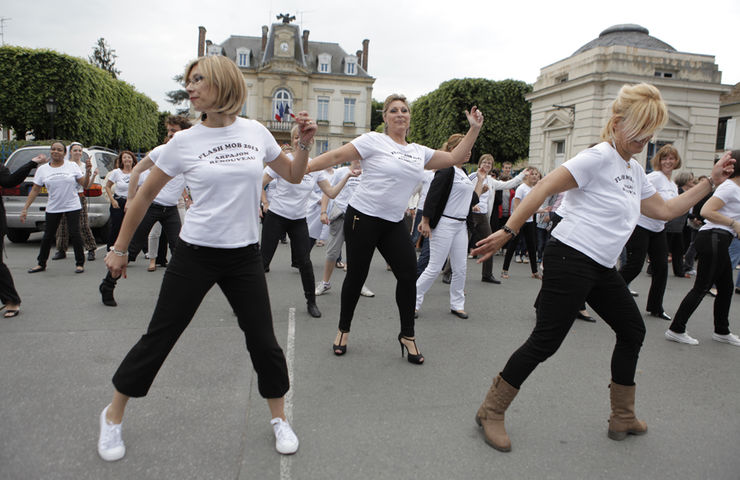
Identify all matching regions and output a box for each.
[473,83,733,452]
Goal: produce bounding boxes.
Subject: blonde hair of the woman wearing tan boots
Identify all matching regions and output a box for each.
[601,83,668,142]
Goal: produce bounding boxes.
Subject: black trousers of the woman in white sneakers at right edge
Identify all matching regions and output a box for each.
[671,229,735,335]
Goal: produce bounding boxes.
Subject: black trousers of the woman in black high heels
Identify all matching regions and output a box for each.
[339,205,416,337]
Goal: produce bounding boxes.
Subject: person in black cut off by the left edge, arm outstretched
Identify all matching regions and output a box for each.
[0,150,48,318]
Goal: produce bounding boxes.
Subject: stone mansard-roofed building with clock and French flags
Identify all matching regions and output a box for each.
[198,16,375,155]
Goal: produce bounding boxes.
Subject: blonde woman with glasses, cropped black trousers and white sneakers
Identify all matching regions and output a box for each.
[98,56,316,461]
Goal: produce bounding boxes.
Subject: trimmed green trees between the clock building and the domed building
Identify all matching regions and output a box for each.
[409,78,532,163]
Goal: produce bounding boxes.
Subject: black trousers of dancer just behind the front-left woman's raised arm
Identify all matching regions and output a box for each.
[262,210,316,300]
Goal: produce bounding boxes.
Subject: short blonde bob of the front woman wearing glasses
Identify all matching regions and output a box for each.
[185,55,247,115]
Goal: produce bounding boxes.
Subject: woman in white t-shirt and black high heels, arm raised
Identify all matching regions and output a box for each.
[309,94,483,365]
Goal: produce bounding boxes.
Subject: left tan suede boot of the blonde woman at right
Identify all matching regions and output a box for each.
[475,375,519,452]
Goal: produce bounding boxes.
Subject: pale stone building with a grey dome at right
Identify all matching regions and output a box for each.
[527,24,731,174]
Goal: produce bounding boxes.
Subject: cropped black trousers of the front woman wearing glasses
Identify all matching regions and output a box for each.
[113,240,289,398]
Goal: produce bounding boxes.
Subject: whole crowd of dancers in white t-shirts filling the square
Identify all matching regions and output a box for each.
[0,56,740,461]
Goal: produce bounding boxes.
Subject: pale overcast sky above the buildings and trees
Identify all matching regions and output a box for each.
[0,0,740,110]
